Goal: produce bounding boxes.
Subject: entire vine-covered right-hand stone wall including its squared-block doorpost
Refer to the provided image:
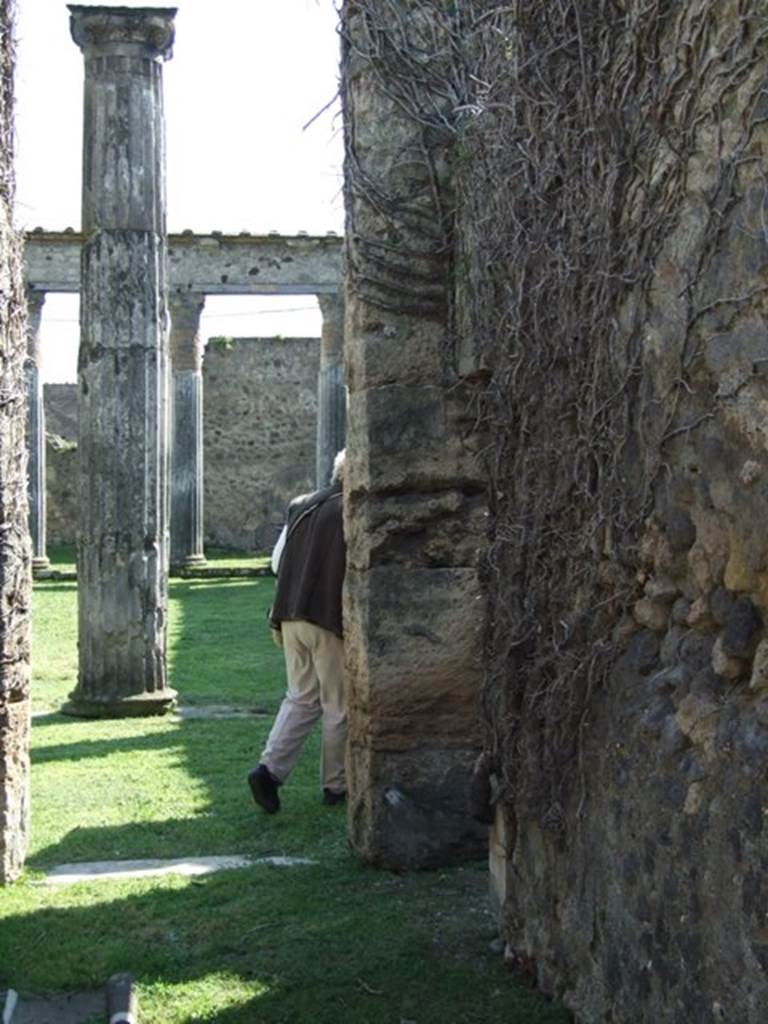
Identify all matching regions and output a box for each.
[344,0,768,1024]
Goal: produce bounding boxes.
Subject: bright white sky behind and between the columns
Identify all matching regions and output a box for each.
[15,0,343,381]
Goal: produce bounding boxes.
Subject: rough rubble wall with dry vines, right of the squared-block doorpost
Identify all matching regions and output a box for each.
[458,0,768,1024]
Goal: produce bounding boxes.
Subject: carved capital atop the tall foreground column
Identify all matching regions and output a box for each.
[67,4,177,60]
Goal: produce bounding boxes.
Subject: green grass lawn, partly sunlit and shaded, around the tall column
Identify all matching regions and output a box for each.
[0,579,568,1024]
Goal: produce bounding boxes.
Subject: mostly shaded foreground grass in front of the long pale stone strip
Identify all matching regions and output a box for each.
[0,862,567,1024]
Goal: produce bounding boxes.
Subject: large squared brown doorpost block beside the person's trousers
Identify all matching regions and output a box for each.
[344,565,483,753]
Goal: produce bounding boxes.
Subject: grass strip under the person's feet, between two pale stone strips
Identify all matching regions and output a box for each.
[28,718,331,870]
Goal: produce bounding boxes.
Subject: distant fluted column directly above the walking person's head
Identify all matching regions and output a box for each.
[316,295,347,487]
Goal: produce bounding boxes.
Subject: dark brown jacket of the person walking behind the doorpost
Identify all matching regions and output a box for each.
[270,483,346,637]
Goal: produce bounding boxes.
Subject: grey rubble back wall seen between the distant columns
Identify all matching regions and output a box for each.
[45,338,319,551]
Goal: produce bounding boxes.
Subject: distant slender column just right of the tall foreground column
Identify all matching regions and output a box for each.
[170,292,206,566]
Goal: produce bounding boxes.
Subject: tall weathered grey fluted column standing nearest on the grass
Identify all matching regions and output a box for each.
[66,5,176,716]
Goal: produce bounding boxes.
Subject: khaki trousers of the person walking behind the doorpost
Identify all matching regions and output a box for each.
[260,622,347,793]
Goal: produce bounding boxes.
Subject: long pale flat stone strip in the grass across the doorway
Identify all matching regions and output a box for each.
[40,856,317,886]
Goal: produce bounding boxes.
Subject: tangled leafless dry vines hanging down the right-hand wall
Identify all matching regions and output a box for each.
[348,0,768,830]
